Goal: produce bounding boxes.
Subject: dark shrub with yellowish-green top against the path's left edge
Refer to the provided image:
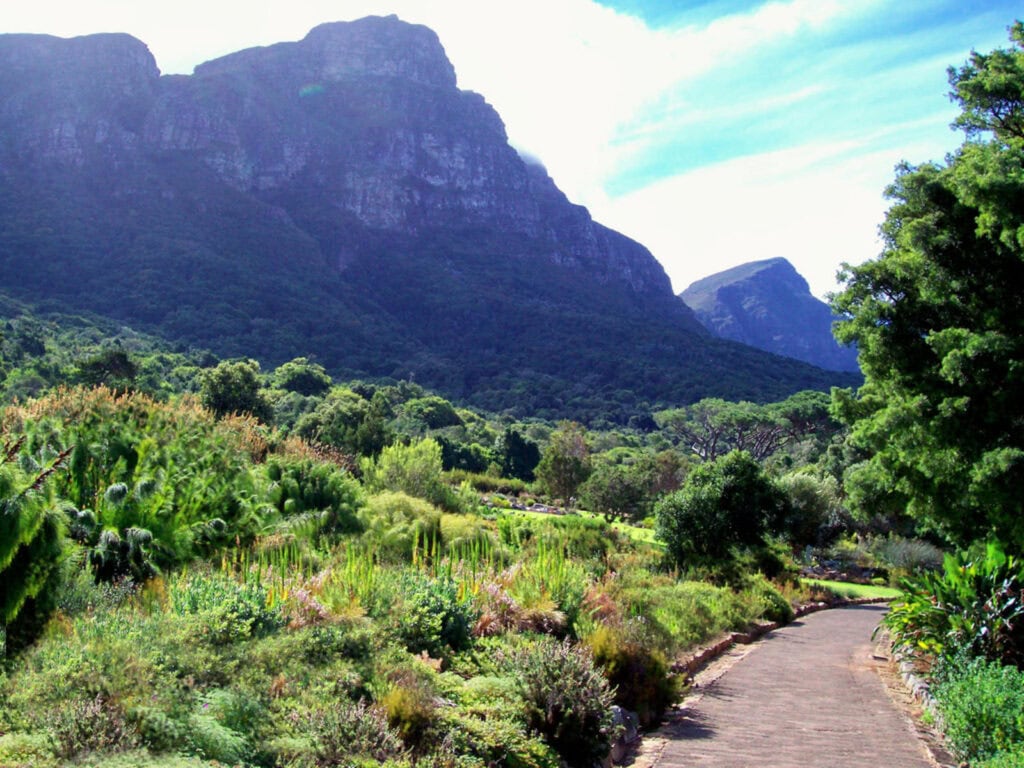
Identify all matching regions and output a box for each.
[587,625,679,728]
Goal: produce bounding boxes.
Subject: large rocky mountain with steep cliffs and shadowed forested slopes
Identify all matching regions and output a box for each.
[0,16,856,418]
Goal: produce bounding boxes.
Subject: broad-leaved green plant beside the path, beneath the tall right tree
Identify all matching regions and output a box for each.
[883,544,1024,666]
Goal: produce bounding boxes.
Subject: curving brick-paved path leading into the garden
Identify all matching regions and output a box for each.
[654,605,937,768]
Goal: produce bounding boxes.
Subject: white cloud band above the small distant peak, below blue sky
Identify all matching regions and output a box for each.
[594,127,942,297]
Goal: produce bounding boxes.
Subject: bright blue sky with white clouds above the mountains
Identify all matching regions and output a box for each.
[0,0,1024,296]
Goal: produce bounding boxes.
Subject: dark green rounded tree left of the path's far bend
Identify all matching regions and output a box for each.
[654,451,785,565]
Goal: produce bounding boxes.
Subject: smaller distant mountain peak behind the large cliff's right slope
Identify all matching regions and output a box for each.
[679,258,860,373]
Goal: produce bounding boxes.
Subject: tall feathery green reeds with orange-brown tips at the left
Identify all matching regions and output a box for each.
[5,387,266,579]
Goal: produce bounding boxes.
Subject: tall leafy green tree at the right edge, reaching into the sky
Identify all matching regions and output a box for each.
[833,23,1024,549]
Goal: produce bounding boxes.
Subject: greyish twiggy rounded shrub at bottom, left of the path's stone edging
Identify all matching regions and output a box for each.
[514,637,614,768]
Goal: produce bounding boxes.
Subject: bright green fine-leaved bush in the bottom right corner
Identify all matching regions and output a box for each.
[932,658,1024,765]
